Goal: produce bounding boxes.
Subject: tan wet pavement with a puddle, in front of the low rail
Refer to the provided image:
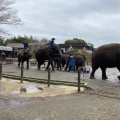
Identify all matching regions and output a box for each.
[0,78,77,97]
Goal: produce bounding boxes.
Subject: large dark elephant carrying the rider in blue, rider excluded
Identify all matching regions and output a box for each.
[35,46,61,71]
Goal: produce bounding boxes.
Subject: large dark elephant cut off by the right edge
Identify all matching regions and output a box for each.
[90,43,120,80]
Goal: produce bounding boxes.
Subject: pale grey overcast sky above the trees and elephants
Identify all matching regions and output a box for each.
[2,0,120,47]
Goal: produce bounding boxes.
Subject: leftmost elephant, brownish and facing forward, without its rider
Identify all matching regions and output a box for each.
[17,49,32,69]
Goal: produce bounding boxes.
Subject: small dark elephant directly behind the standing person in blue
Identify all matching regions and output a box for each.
[65,55,85,71]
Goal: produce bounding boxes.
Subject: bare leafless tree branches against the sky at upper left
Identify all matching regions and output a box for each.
[0,0,22,34]
